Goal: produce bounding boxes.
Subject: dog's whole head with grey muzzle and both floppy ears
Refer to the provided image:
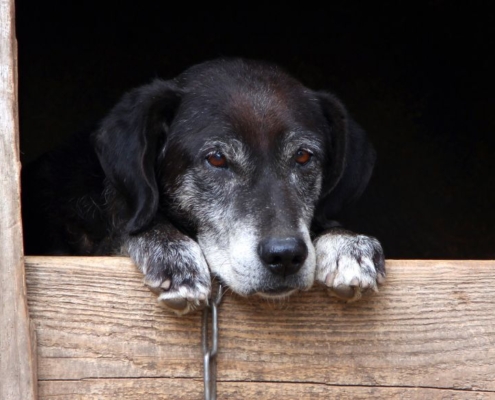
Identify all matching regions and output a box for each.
[94,59,374,297]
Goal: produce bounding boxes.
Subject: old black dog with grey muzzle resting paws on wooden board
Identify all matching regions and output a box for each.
[22,58,385,315]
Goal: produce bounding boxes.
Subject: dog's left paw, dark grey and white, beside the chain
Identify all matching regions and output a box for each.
[127,237,211,315]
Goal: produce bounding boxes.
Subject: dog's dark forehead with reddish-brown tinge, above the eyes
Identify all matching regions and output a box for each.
[180,62,319,148]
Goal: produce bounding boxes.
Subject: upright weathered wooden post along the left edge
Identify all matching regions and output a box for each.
[0,0,37,400]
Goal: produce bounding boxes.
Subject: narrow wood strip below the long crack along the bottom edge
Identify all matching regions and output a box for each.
[40,378,495,400]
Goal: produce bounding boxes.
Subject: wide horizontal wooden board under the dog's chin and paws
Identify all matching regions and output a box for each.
[26,257,495,399]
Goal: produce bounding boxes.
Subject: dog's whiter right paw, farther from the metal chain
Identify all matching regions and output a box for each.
[314,230,385,301]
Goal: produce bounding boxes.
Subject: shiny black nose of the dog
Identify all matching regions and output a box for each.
[258,237,308,276]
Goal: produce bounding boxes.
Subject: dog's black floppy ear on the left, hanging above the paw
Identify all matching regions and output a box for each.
[92,80,180,233]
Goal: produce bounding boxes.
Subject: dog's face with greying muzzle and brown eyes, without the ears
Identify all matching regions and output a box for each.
[162,62,326,296]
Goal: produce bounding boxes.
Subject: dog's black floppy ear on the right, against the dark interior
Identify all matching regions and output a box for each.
[315,92,376,225]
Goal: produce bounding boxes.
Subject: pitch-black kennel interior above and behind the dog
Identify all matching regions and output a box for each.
[16,0,495,259]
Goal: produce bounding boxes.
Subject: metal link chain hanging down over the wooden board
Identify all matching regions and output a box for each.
[202,285,223,400]
